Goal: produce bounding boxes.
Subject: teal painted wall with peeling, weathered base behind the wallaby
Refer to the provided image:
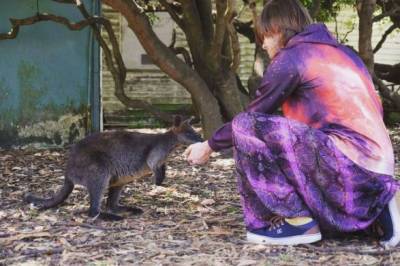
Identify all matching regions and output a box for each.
[0,0,100,148]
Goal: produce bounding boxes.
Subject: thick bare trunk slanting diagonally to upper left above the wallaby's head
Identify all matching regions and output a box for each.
[103,0,223,138]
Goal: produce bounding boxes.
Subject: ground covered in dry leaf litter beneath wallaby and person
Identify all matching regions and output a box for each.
[0,127,400,266]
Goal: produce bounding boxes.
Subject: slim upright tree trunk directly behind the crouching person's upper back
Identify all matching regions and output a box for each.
[357,0,376,74]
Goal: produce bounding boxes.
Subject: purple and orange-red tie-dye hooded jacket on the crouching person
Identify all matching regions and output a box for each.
[208,24,394,175]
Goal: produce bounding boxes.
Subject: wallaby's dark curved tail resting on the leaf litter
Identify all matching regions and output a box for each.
[24,178,74,209]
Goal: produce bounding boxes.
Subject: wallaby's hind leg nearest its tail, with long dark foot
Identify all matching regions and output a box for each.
[87,175,123,221]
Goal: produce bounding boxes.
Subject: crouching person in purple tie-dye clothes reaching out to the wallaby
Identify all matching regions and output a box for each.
[185,0,400,246]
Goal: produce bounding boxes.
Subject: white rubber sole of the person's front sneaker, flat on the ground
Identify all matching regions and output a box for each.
[247,232,322,245]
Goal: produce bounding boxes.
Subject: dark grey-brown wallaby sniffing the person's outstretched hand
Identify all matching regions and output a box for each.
[25,116,202,220]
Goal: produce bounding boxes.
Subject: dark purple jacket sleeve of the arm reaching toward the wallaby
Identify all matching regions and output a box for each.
[208,53,300,151]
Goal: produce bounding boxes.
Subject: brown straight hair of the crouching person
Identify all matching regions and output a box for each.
[255,0,312,45]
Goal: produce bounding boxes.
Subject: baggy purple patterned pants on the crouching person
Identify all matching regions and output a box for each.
[232,113,397,232]
